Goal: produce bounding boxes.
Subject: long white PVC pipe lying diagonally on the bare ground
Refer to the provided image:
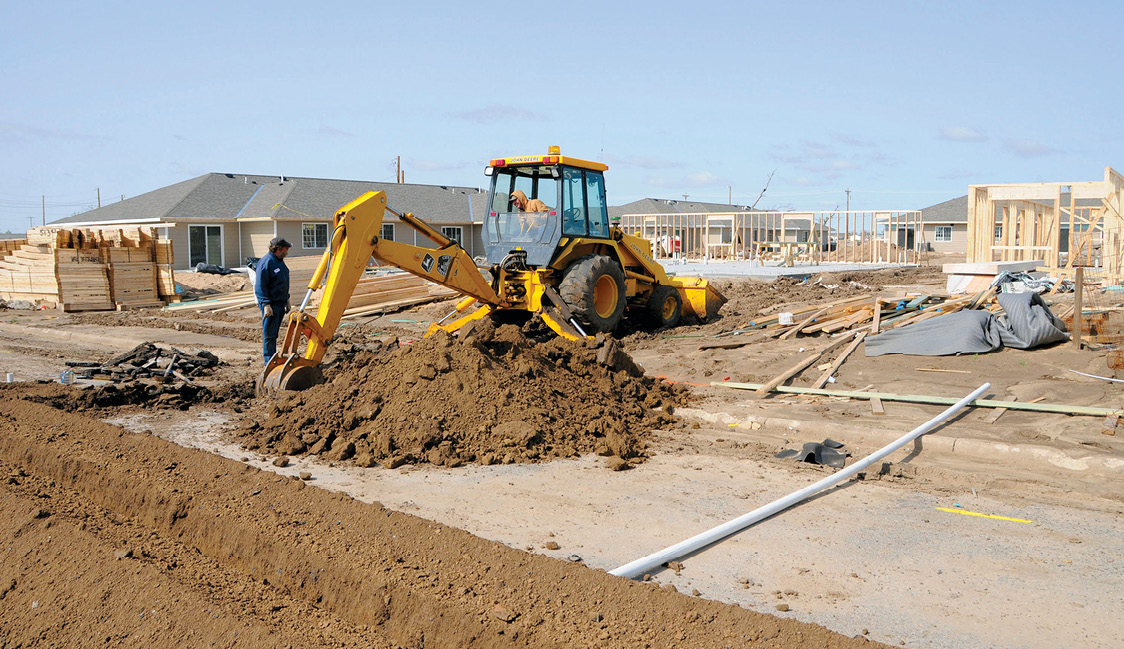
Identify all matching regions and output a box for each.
[609,384,991,579]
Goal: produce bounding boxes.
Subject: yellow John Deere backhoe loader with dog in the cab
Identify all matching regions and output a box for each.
[259,146,726,391]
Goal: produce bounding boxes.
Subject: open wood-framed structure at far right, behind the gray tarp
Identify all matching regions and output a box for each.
[967,166,1124,282]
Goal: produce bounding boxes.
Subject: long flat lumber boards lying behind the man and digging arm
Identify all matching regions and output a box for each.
[165,272,457,319]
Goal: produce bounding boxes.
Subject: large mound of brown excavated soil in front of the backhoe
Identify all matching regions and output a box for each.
[235,322,687,469]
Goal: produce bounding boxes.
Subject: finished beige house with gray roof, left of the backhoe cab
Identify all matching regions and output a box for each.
[48,173,488,269]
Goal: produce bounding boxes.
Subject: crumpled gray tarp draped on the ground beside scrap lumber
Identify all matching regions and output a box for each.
[865,292,1069,357]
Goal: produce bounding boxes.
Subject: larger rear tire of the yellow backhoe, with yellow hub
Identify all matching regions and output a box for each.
[559,254,627,333]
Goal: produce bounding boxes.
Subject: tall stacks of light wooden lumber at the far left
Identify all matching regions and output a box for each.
[0,227,175,312]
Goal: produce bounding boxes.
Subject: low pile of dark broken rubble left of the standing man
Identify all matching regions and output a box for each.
[66,342,220,382]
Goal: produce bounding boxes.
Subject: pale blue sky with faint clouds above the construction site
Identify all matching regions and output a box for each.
[0,0,1124,232]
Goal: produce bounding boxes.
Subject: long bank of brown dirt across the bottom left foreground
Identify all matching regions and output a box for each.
[0,391,885,649]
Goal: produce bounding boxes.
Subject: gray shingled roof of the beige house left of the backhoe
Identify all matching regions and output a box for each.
[52,173,488,225]
